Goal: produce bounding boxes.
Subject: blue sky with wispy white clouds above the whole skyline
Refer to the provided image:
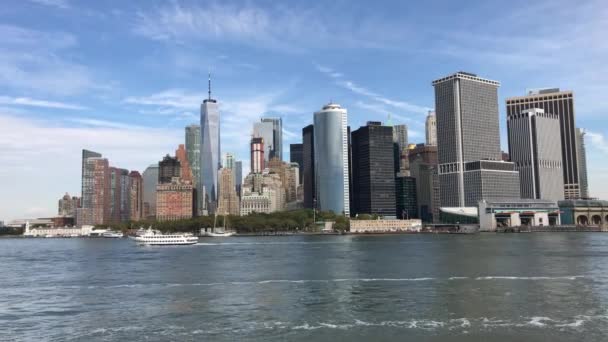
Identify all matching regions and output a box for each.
[0,0,608,220]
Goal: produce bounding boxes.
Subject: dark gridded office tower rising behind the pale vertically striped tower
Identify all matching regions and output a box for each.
[507,88,582,199]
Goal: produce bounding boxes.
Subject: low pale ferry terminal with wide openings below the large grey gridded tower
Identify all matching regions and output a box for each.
[477,199,561,231]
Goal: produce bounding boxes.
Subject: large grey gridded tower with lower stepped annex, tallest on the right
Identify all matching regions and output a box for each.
[433,72,520,207]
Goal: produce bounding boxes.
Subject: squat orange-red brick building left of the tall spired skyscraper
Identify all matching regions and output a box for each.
[156,177,194,221]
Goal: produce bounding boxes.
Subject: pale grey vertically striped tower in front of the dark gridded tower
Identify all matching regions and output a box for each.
[507,108,564,202]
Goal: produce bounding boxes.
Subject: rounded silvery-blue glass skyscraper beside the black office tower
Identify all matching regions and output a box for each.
[314,103,350,216]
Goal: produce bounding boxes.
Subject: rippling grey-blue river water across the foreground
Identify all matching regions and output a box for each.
[0,233,608,341]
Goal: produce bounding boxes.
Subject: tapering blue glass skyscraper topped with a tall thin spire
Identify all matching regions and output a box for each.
[197,76,221,214]
